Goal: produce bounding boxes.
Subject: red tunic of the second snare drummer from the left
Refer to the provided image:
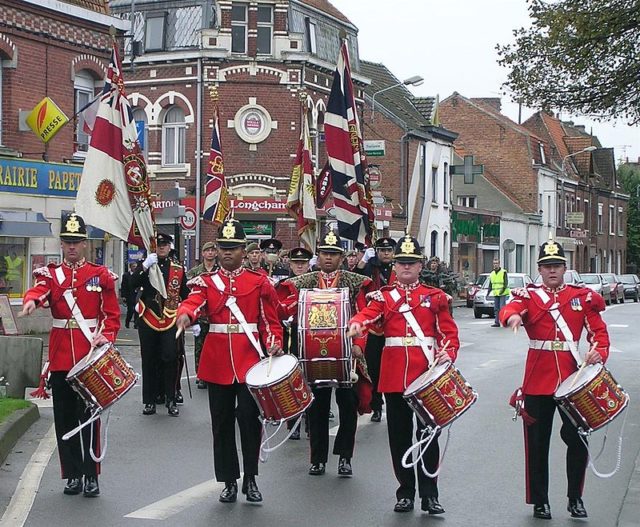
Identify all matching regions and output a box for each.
[178,268,282,384]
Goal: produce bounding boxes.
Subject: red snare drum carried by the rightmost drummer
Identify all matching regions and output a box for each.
[554,364,629,434]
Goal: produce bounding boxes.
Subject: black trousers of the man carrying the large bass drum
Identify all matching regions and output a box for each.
[307,387,358,464]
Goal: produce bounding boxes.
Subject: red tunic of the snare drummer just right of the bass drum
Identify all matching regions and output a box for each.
[351,284,460,393]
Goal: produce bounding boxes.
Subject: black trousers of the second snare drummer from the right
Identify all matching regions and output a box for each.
[384,393,440,500]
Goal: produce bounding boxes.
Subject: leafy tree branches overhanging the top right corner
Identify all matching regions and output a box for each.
[496,0,640,124]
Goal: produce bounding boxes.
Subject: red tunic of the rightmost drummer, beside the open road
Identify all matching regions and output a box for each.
[500,285,609,395]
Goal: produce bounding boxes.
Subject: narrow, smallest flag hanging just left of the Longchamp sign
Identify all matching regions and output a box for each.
[202,104,231,224]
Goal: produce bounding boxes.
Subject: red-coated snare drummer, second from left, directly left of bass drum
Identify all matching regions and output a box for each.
[177,219,282,503]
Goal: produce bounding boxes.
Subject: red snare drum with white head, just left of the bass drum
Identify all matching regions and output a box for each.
[245,355,313,421]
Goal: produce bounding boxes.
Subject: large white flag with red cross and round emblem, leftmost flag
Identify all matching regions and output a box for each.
[75,44,167,298]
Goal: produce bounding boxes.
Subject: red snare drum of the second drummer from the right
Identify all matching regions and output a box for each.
[403,362,478,428]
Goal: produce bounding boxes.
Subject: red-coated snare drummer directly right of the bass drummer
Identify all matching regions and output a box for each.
[350,235,459,514]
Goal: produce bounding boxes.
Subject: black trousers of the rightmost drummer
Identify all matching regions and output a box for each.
[524,395,588,504]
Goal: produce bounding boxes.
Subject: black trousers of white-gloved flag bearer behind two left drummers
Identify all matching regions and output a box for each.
[138,320,178,404]
